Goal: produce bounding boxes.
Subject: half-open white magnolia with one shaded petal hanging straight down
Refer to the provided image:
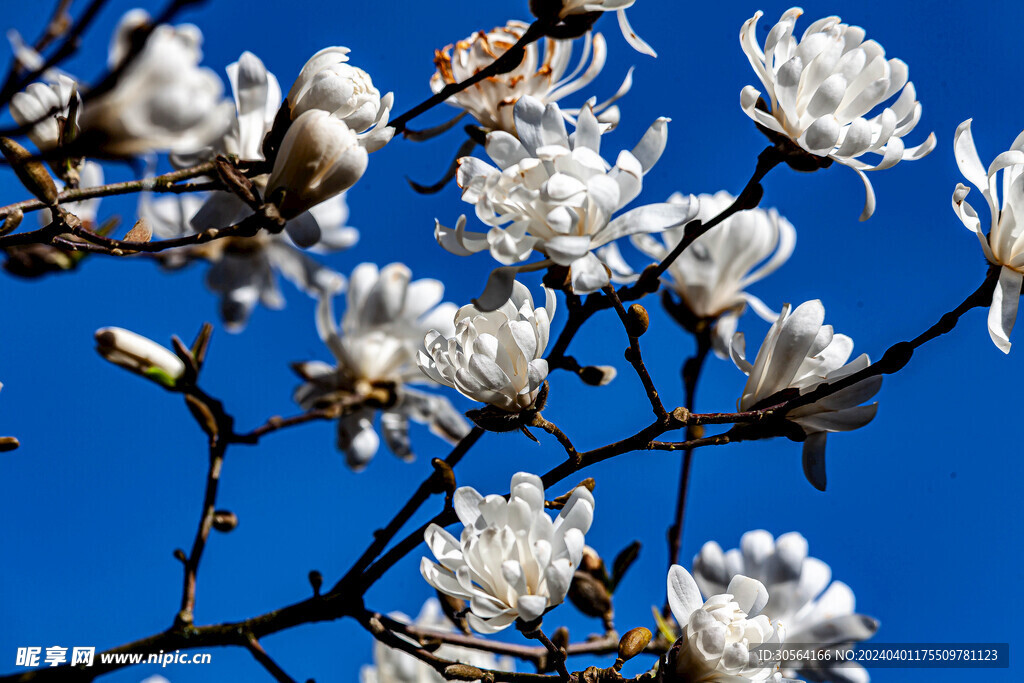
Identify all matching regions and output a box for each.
[731,299,882,490]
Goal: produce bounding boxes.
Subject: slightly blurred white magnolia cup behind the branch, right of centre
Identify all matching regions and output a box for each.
[630,191,797,358]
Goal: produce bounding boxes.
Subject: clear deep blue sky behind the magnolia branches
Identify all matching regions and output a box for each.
[0,0,1024,683]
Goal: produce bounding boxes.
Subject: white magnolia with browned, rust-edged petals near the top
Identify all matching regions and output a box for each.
[430,20,633,135]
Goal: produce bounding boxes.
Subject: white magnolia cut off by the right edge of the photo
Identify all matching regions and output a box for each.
[953,119,1024,353]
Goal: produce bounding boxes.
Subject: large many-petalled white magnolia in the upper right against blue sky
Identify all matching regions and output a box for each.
[739,7,935,220]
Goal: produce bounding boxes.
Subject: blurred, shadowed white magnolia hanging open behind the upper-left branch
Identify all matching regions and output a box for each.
[144,193,358,332]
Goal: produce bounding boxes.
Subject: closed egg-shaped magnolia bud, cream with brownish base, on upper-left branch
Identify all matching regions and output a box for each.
[266,110,368,219]
